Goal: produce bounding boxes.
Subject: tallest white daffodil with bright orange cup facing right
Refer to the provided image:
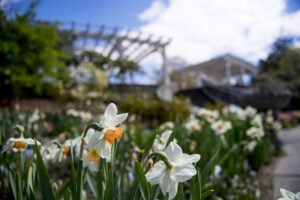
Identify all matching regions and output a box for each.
[86,103,128,159]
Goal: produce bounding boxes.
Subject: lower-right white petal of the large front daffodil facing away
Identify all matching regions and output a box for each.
[171,164,197,182]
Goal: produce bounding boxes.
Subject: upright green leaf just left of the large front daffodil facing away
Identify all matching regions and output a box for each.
[135,160,150,200]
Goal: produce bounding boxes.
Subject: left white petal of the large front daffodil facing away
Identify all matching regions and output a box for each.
[146,161,166,185]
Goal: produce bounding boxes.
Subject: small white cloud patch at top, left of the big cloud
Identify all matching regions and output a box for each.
[139,0,166,21]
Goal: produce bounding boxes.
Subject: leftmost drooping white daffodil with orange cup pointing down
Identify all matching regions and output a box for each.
[2,137,41,152]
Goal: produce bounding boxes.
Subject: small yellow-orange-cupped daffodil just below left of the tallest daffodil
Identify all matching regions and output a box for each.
[82,148,100,172]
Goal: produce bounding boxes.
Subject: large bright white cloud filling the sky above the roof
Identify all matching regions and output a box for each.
[139,0,300,69]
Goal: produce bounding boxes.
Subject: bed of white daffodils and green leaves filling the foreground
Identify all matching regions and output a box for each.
[0,103,278,200]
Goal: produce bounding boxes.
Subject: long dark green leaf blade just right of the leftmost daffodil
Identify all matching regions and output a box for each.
[34,141,55,200]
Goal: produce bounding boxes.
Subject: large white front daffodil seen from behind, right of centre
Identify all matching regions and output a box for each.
[146,142,200,199]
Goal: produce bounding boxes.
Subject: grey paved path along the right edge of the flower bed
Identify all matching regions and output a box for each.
[273,126,300,200]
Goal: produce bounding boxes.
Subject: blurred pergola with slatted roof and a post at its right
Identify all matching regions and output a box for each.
[43,22,171,83]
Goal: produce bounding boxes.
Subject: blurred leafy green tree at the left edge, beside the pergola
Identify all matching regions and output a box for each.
[0,4,68,103]
